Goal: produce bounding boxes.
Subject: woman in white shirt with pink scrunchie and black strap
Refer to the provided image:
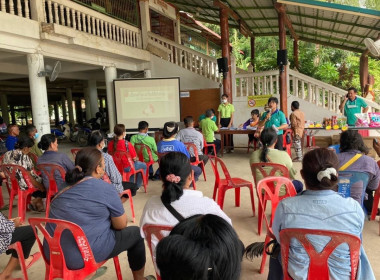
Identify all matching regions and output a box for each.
[140,152,231,255]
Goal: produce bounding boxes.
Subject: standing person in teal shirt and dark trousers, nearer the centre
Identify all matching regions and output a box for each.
[258,97,289,151]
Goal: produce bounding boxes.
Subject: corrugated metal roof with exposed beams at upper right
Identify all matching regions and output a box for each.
[168,0,380,52]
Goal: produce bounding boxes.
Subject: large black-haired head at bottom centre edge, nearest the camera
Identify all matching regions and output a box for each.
[156,214,244,280]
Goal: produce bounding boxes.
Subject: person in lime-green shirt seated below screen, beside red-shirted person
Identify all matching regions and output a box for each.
[130,121,158,179]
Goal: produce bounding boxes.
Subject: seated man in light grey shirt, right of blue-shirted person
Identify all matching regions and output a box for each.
[176,116,208,164]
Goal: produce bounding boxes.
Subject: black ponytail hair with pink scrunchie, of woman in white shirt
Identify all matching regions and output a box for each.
[160,152,191,203]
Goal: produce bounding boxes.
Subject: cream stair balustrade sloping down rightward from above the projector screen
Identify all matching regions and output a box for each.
[148,32,220,82]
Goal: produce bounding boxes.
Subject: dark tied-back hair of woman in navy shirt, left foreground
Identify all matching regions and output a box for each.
[65,147,102,185]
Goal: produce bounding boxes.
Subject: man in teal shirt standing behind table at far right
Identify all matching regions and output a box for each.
[339,87,368,126]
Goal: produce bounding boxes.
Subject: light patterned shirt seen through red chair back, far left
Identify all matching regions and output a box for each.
[3,149,42,190]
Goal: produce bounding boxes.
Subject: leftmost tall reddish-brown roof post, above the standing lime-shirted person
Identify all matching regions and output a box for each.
[219,8,232,103]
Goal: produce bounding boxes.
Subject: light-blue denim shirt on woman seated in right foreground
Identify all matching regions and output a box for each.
[272,190,376,280]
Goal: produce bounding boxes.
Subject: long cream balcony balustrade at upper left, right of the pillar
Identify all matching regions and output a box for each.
[42,0,141,48]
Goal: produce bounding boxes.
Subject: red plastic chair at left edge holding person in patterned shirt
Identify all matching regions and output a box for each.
[1,164,37,222]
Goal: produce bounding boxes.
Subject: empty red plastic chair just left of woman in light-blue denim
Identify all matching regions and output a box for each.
[257,177,297,273]
